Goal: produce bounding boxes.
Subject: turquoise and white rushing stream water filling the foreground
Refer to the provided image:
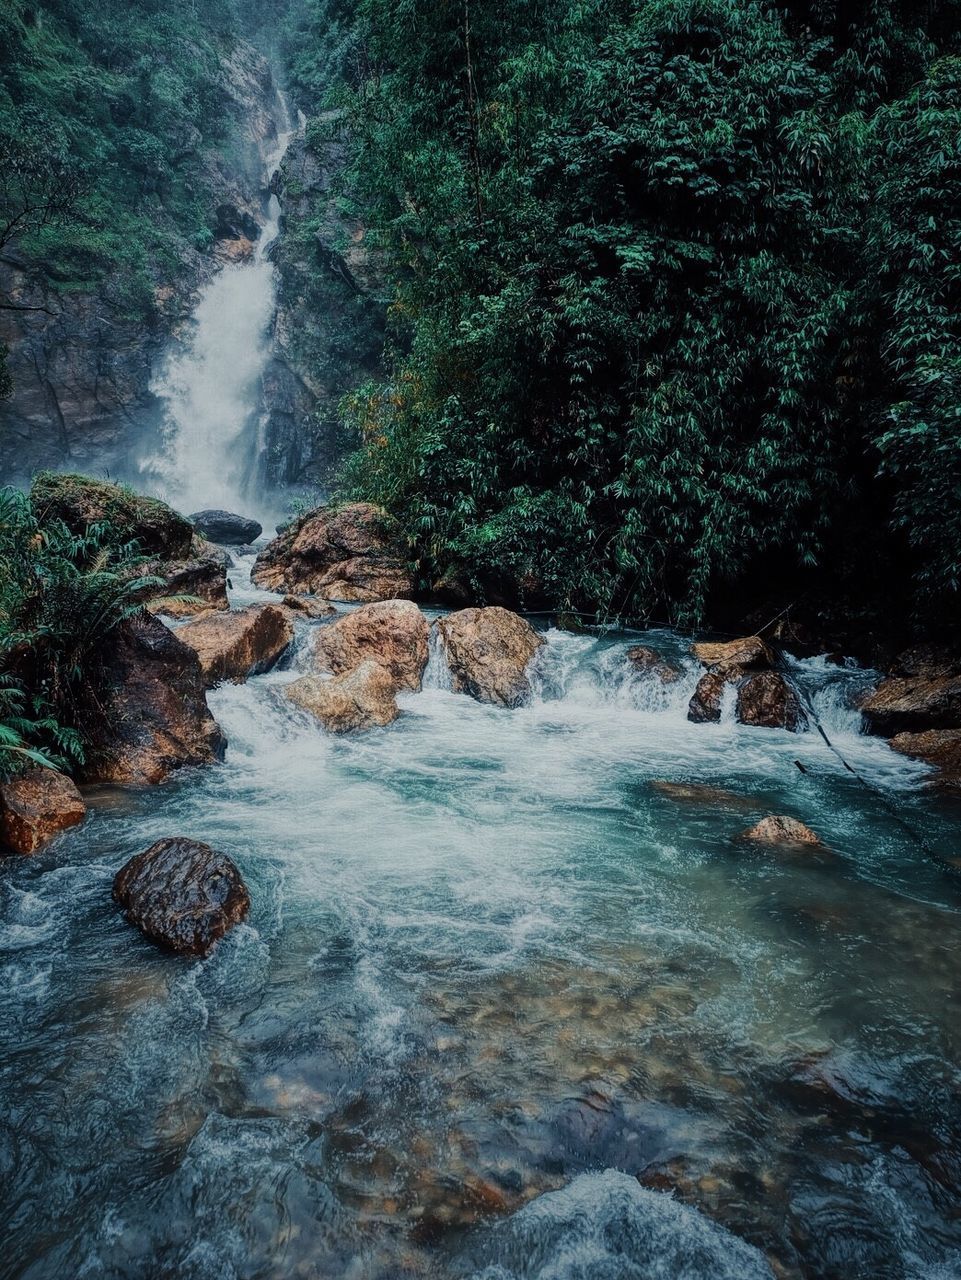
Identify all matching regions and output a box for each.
[0,573,961,1280]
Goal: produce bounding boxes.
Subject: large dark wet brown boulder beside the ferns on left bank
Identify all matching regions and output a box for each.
[81,613,226,785]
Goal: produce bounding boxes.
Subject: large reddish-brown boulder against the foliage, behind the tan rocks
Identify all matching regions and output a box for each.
[253,502,413,604]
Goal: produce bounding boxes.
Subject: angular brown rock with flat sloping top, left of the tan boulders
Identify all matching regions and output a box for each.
[177,604,293,689]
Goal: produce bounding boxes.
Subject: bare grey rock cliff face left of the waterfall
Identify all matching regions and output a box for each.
[0,42,276,481]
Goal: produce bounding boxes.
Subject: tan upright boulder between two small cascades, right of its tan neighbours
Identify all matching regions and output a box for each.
[438,605,544,707]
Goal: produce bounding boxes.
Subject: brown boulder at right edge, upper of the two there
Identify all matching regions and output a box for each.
[861,645,961,737]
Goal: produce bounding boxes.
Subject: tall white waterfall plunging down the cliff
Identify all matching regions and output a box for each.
[142,95,294,512]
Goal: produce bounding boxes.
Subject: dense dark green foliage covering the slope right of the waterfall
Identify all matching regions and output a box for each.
[290,0,961,625]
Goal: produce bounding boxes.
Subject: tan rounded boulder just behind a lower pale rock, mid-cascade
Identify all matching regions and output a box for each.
[314,600,429,690]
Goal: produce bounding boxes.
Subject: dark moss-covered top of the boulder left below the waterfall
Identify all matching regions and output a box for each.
[29,471,193,561]
